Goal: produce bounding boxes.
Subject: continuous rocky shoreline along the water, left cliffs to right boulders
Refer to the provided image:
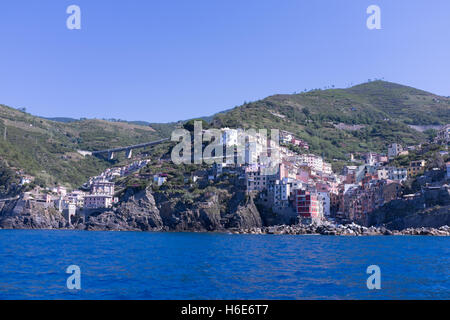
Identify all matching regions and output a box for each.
[0,190,450,236]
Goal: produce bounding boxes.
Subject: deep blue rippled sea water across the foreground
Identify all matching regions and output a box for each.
[0,230,450,299]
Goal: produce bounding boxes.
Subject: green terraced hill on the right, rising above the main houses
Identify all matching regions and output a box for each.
[213,81,450,160]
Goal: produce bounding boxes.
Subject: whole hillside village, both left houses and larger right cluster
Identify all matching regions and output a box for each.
[10,125,450,223]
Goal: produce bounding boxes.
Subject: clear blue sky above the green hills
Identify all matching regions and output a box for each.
[0,0,450,122]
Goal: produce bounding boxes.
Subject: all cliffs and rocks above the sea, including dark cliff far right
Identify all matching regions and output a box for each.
[0,189,450,235]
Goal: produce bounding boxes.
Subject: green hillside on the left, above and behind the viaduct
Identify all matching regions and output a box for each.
[0,105,174,186]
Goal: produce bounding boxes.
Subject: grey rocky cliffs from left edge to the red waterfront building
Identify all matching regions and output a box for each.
[0,189,263,231]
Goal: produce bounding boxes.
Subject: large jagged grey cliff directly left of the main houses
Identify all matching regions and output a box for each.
[81,186,262,231]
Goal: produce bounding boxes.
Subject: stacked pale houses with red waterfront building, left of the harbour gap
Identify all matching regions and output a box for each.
[208,128,339,222]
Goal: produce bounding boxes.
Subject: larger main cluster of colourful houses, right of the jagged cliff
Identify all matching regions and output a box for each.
[205,126,450,222]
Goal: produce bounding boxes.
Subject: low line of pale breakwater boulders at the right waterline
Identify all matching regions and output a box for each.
[230,223,450,236]
